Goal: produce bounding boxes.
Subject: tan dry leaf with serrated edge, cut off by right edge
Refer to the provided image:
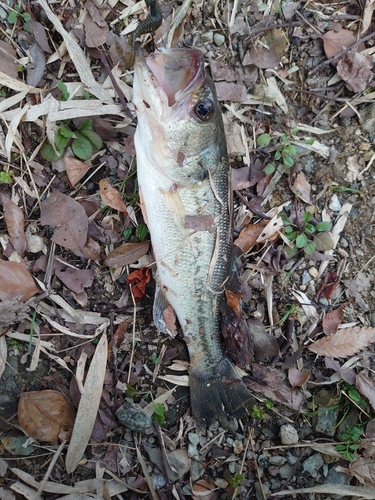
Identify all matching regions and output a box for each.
[308,326,375,358]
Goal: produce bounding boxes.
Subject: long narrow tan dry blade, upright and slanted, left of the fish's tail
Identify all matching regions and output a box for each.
[65,333,107,473]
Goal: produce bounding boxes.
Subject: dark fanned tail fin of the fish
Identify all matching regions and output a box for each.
[189,357,253,428]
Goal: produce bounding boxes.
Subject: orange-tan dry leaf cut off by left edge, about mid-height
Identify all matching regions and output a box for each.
[0,260,40,301]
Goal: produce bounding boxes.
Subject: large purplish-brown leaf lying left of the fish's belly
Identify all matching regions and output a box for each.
[40,190,88,256]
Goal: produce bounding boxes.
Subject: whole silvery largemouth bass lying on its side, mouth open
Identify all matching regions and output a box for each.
[133,49,252,427]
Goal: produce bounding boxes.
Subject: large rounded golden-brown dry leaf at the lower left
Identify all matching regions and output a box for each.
[18,390,76,442]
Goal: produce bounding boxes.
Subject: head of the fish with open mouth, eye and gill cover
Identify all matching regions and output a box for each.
[133,48,226,183]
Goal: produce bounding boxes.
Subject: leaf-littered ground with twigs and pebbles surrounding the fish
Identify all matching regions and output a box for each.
[0,0,375,500]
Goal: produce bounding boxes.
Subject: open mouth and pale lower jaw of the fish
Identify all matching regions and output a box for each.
[134,49,205,112]
